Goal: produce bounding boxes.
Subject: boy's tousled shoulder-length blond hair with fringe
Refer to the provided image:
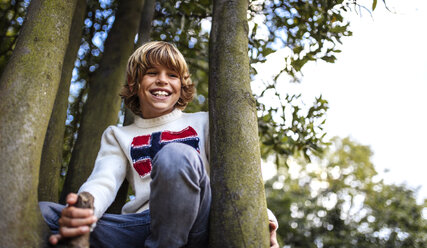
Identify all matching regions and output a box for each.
[120,41,195,116]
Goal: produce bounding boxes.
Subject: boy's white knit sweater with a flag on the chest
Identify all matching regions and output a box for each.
[79,109,209,218]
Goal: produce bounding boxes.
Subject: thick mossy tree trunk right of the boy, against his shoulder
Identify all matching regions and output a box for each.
[209,0,269,248]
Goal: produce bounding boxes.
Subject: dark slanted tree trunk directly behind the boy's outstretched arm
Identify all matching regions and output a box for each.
[60,0,143,202]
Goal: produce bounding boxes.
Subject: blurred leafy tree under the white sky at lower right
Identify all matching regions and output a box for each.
[266,138,427,248]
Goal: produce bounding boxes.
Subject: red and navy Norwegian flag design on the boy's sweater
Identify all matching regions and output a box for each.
[130,126,200,177]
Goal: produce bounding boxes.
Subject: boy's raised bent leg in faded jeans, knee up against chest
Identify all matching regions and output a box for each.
[145,143,211,248]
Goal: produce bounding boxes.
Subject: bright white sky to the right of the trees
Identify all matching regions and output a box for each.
[256,0,427,200]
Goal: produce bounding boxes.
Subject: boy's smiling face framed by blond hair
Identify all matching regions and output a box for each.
[138,65,181,119]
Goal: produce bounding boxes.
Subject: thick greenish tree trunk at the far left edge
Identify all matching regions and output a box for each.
[0,0,76,247]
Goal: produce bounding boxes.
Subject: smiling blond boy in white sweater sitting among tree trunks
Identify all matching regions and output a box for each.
[40,42,278,247]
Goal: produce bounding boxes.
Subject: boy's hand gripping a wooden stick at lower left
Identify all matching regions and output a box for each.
[49,193,97,245]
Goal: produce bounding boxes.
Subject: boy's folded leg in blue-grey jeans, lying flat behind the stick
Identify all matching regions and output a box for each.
[39,202,150,248]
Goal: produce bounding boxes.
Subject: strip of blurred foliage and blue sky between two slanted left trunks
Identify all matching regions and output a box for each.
[61,0,117,185]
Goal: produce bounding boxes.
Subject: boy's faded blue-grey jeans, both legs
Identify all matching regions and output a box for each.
[39,143,211,248]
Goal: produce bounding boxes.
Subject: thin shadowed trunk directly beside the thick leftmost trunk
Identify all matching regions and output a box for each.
[38,0,87,202]
